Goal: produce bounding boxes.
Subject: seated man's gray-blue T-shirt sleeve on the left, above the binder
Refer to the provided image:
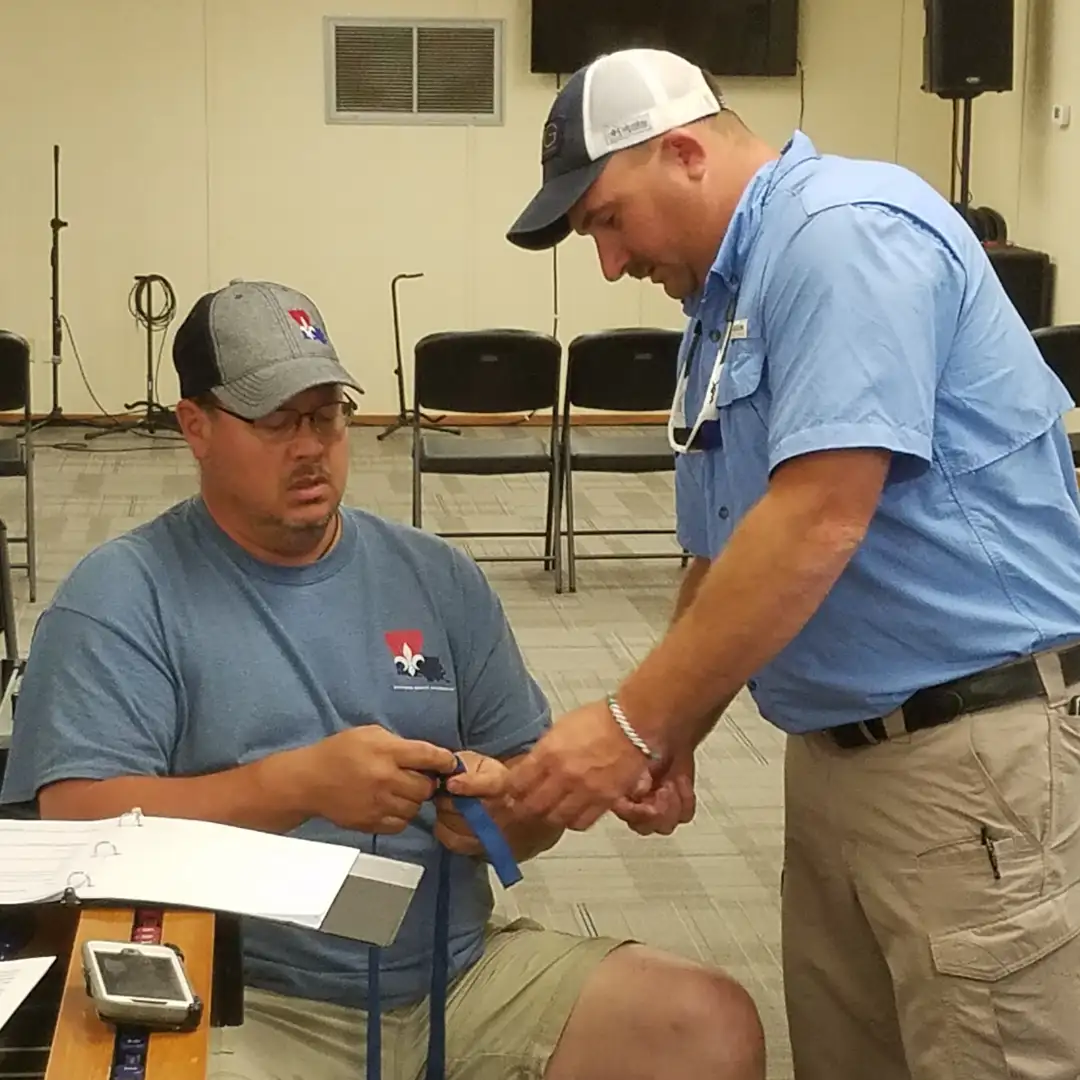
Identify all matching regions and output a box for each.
[0,606,177,802]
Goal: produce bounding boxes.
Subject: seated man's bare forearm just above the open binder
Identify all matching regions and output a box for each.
[38,750,312,833]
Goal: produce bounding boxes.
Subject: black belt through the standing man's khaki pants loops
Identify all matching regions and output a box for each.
[828,645,1080,750]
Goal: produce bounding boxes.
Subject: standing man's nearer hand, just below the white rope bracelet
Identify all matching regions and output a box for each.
[509,701,651,831]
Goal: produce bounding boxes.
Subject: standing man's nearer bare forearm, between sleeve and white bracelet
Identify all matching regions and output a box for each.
[619,460,873,753]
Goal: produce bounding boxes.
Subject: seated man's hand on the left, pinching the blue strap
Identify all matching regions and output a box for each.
[293,724,457,833]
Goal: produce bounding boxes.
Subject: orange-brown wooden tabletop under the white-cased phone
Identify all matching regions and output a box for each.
[0,907,215,1080]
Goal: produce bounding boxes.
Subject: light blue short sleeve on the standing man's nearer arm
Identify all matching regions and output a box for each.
[762,205,963,470]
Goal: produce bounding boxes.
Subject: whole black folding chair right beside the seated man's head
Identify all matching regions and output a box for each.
[413,329,563,580]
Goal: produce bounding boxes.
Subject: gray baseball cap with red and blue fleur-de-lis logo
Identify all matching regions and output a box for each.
[173,281,364,420]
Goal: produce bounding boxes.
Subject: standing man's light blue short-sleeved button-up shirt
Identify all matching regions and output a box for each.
[676,132,1080,732]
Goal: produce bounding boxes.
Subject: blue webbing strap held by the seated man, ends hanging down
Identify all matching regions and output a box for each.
[367,758,522,1080]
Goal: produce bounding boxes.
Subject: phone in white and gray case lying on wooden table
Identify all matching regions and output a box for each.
[82,941,203,1031]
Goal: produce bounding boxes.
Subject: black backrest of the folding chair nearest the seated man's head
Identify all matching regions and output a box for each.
[414,329,563,413]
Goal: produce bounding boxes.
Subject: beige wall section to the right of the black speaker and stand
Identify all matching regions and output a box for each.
[971,0,1080,323]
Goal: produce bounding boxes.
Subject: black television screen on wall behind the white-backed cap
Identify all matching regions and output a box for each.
[531,0,798,76]
